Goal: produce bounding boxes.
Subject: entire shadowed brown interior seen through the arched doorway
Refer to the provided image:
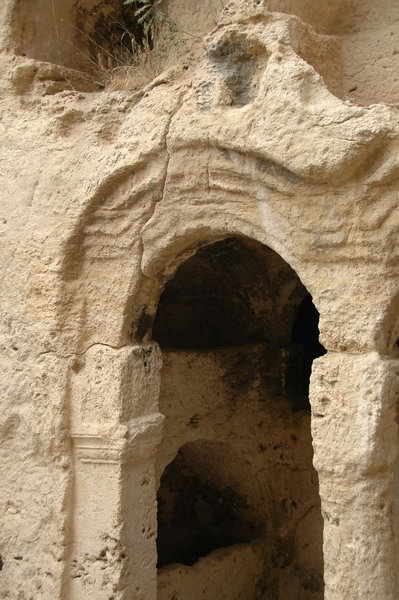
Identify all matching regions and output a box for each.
[153,237,325,600]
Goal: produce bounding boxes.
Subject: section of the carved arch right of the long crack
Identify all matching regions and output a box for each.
[138,146,324,340]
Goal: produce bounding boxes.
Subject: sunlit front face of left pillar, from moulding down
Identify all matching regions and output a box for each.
[68,434,125,600]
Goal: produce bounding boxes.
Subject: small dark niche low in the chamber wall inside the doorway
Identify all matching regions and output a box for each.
[157,440,259,567]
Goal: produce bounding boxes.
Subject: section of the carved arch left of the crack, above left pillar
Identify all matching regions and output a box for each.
[59,152,167,351]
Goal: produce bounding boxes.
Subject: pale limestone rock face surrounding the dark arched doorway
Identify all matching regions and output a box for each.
[0,0,399,600]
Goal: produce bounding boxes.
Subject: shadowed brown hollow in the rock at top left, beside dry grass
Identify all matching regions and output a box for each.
[11,0,151,76]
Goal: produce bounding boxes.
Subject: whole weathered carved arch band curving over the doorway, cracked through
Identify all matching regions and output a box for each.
[60,147,324,350]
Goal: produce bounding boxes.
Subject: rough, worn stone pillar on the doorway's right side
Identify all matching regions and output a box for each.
[311,353,399,600]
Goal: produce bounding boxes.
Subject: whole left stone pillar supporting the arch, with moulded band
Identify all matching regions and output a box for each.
[64,345,163,600]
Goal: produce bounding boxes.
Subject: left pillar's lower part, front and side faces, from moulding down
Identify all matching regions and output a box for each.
[70,413,163,600]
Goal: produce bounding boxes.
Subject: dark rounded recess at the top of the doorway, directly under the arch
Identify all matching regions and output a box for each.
[153,237,325,409]
